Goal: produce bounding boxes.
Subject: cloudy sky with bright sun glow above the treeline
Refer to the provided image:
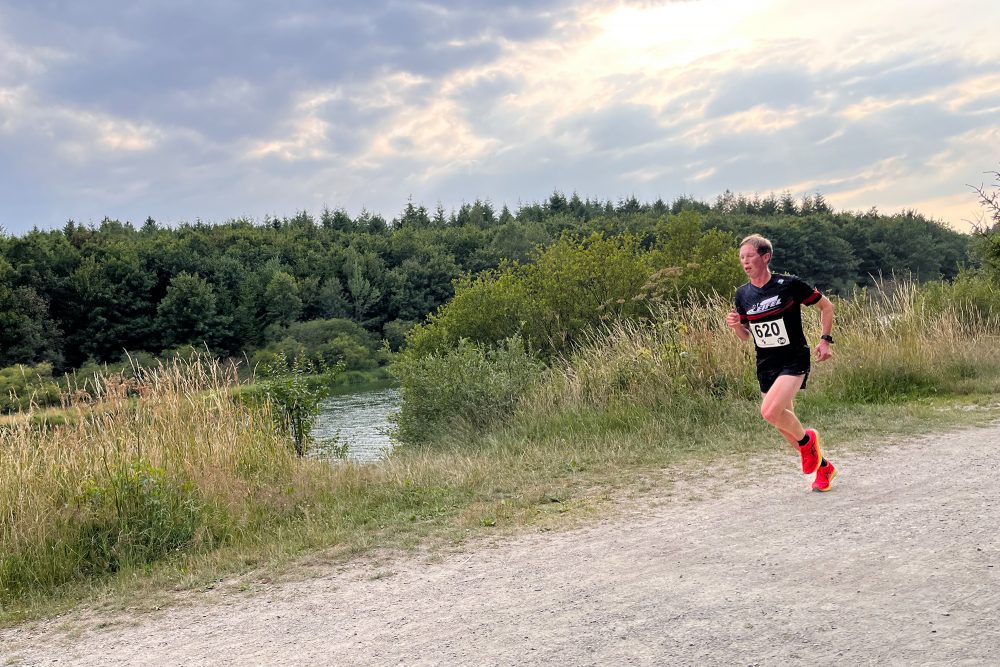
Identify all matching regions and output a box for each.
[0,0,1000,233]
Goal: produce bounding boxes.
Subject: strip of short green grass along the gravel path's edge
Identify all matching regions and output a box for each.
[0,395,1000,624]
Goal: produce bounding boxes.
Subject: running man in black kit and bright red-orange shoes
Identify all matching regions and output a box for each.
[726,234,837,491]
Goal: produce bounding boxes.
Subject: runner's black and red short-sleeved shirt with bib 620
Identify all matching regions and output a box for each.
[736,273,823,362]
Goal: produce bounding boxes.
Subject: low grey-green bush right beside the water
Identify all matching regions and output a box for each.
[391,336,543,444]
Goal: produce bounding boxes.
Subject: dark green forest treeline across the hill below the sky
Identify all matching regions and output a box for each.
[0,192,971,374]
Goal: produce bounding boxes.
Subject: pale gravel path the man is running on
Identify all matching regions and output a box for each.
[0,426,1000,665]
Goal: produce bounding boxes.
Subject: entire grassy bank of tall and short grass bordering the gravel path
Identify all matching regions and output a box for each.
[0,289,1000,623]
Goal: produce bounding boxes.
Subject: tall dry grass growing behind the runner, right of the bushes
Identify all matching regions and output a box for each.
[519,283,1000,419]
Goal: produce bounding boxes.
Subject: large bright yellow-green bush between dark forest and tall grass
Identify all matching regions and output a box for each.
[407,219,744,358]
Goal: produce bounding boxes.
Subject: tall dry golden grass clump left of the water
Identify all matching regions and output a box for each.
[0,359,328,601]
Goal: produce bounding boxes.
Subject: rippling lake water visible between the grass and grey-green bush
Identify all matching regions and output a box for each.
[310,388,400,461]
